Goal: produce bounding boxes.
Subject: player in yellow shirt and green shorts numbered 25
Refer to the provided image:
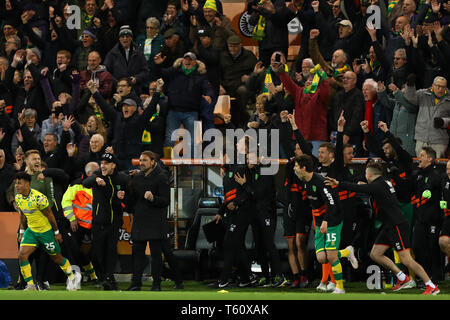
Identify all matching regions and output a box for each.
[15,172,81,290]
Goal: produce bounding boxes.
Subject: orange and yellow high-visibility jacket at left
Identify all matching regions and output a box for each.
[61,184,93,229]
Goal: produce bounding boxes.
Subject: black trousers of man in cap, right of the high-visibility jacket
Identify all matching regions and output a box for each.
[92,225,119,279]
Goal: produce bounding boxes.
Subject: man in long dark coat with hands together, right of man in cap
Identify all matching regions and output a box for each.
[127,151,182,291]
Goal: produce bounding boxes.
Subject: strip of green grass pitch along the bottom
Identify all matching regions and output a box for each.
[0,280,450,301]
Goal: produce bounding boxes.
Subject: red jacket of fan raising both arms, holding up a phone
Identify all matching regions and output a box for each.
[279,72,330,141]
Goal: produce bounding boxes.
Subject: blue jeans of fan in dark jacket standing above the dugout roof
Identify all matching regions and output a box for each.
[164,110,198,156]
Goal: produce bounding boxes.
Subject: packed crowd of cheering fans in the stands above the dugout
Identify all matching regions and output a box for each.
[0,0,450,292]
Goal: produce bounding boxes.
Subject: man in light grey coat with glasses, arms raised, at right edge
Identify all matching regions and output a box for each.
[405,77,450,158]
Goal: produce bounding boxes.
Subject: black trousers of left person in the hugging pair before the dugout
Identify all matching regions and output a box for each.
[220,210,251,282]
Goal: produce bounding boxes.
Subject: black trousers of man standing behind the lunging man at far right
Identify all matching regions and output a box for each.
[412,220,443,282]
